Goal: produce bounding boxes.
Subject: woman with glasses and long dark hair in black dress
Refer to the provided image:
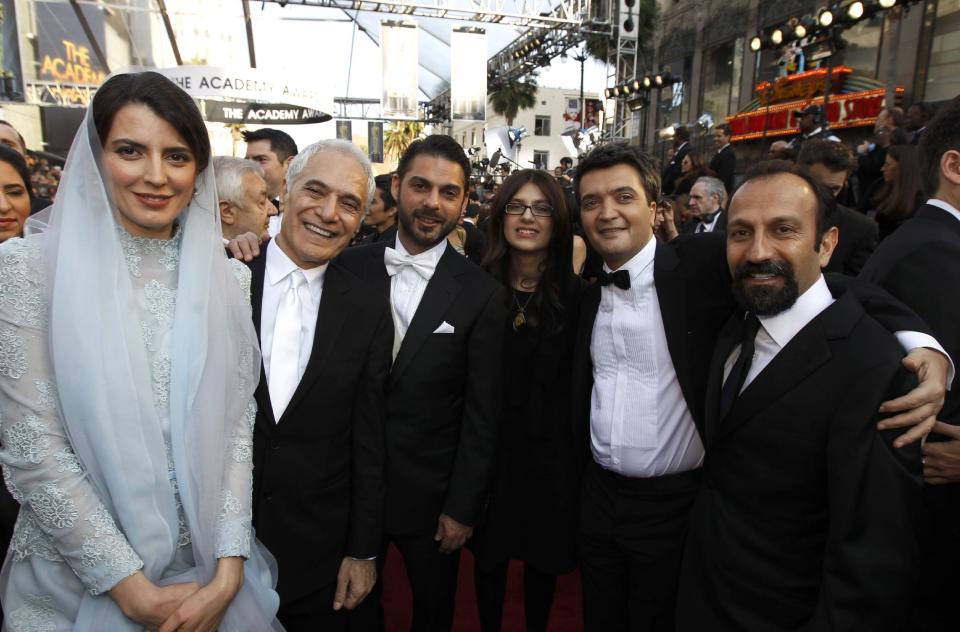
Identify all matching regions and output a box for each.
[473,169,582,632]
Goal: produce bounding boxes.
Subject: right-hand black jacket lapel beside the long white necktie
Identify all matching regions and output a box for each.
[280,261,350,425]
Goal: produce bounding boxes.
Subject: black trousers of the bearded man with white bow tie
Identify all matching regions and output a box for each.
[361,533,460,632]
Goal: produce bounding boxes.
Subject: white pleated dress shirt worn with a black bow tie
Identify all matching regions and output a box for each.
[590,239,703,478]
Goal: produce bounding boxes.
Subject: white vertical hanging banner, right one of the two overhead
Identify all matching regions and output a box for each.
[450,27,487,121]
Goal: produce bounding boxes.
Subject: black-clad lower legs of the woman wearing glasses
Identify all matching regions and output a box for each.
[473,560,557,632]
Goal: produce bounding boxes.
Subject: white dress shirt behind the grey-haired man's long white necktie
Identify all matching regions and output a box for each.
[260,239,328,396]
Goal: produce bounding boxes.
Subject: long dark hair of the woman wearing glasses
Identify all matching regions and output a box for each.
[481,169,575,334]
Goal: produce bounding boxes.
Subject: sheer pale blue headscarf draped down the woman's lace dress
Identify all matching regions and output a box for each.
[23,73,282,631]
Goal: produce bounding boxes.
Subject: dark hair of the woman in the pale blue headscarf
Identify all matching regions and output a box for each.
[93,72,210,173]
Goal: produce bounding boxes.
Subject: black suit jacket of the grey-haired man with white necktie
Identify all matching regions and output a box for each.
[250,249,393,603]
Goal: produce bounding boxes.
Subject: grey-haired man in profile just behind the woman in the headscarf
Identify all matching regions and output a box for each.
[213,156,271,240]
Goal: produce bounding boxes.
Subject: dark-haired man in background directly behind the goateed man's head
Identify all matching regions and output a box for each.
[797,139,880,276]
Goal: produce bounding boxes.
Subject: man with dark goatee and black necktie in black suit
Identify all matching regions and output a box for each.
[677,159,920,632]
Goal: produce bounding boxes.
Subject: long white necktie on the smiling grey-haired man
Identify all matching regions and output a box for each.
[268,270,307,422]
